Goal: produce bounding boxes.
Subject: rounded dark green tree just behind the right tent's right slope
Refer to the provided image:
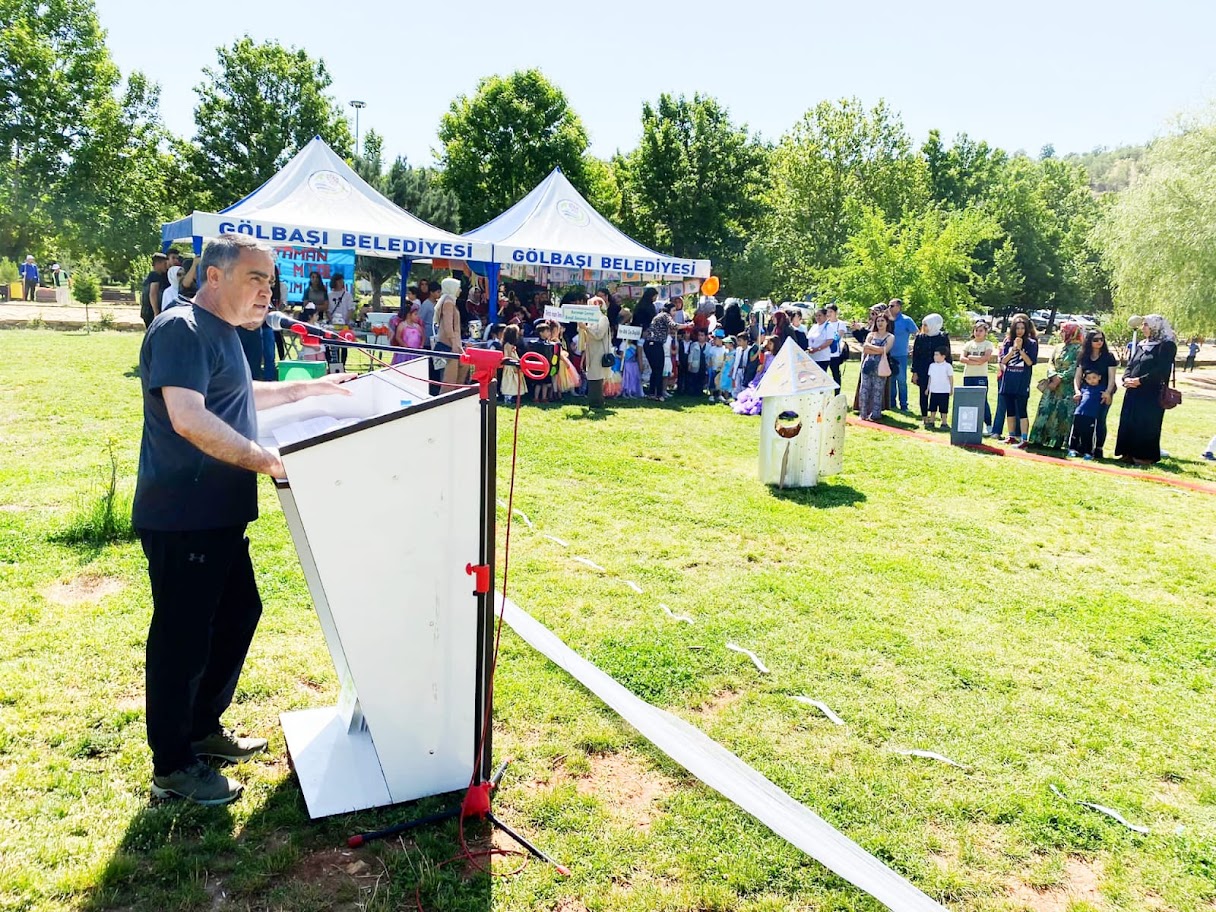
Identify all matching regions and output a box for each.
[620,94,767,274]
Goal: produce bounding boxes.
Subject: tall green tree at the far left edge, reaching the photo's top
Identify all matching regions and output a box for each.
[0,0,176,272]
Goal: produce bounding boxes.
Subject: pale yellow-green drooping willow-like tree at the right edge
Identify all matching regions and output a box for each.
[1096,107,1216,334]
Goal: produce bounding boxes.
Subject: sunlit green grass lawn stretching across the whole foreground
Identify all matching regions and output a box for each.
[0,331,1216,912]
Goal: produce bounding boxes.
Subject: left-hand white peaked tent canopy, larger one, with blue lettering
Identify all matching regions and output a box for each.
[161,136,492,263]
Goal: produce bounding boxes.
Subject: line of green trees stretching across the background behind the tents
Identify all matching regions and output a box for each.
[0,0,1216,332]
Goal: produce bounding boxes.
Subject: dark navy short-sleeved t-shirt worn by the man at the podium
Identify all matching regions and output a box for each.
[131,304,258,531]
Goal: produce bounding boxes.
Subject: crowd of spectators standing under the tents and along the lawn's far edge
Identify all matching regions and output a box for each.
[128,249,1199,465]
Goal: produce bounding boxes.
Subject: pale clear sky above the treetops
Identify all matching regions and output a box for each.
[97,0,1216,164]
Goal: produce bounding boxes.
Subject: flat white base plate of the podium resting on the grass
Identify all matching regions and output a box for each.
[278,708,393,820]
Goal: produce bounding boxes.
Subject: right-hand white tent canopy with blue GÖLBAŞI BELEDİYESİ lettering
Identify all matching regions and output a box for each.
[465,168,711,320]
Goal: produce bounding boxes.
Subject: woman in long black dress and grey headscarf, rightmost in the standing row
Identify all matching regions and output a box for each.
[1115,314,1178,466]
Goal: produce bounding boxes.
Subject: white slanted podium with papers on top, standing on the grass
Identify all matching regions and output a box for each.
[258,359,494,818]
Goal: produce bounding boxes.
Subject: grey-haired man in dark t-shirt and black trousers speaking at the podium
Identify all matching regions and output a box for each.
[131,235,350,805]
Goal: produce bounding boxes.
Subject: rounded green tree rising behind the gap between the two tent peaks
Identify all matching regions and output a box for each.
[439,69,591,229]
